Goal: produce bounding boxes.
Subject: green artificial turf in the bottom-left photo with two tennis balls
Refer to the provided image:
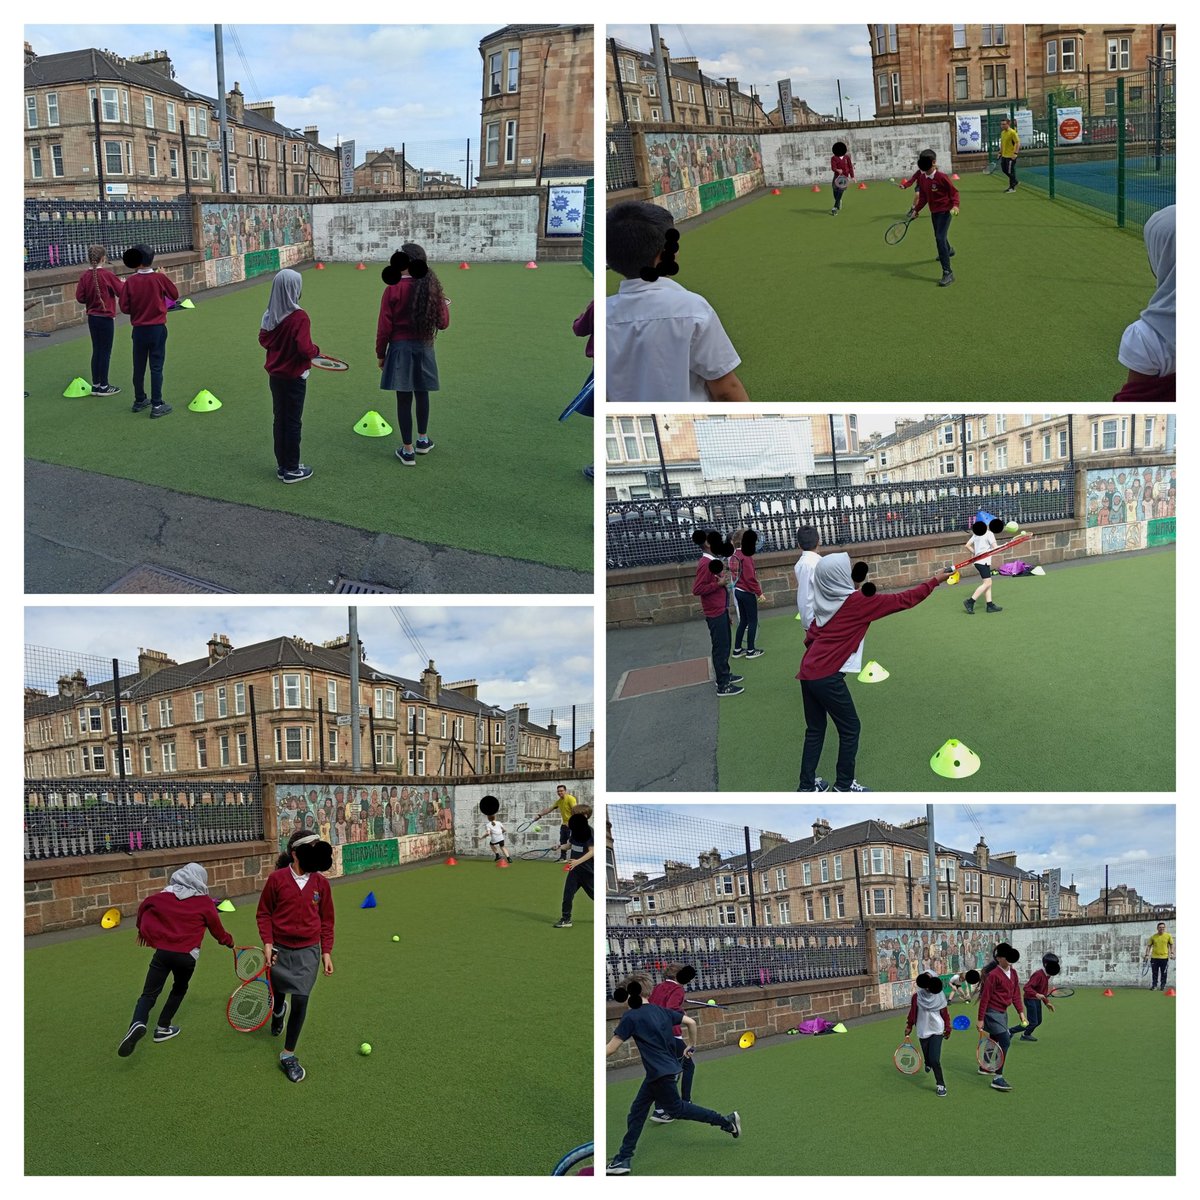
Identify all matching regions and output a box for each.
[25,862,594,1177]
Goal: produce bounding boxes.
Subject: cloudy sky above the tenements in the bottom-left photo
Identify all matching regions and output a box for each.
[25,605,593,724]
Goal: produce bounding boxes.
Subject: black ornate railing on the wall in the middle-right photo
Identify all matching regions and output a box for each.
[605,467,1075,569]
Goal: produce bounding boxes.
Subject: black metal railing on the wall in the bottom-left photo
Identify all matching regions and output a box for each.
[24,779,263,862]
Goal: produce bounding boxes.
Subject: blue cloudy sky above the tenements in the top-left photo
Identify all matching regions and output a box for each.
[25,21,504,174]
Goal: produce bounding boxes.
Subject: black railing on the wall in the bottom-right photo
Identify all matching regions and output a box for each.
[605,922,868,996]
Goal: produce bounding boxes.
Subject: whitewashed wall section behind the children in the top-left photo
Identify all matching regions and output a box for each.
[312,188,544,266]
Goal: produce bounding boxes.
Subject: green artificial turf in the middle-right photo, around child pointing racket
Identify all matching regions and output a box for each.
[718,551,1175,792]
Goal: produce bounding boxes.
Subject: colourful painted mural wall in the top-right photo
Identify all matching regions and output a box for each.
[640,130,763,221]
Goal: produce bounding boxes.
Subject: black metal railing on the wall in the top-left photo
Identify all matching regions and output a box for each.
[25,199,194,271]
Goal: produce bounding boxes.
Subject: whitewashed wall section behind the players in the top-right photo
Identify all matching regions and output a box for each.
[760,119,954,184]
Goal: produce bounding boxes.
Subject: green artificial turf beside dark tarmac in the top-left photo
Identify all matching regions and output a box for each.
[25,263,593,571]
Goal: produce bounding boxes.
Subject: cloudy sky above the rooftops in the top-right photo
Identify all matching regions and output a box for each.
[606,24,875,121]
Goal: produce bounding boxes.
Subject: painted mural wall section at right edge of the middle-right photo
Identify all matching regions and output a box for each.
[1086,463,1176,554]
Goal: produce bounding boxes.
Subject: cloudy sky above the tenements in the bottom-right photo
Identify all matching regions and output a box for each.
[608,804,1176,904]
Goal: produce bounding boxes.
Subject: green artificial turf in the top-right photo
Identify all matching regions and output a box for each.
[607,175,1154,403]
